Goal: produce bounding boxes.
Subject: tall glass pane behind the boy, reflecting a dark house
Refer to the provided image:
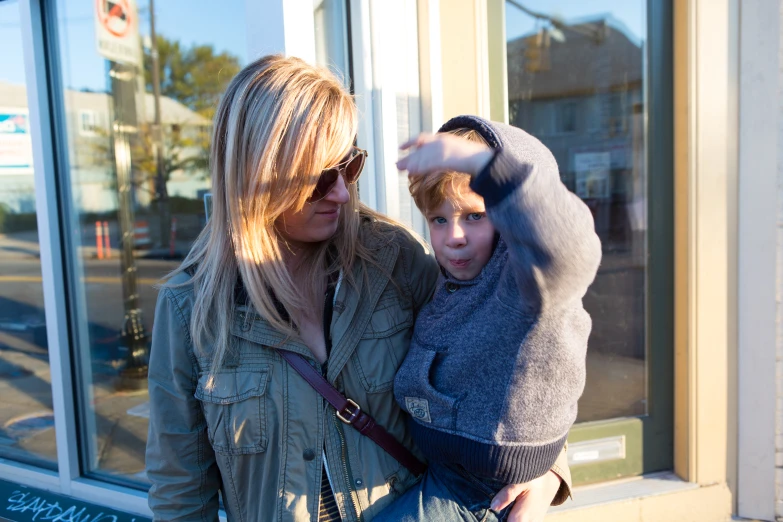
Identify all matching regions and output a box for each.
[506,0,647,421]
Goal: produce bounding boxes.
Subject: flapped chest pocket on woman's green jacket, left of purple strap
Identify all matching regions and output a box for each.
[195,366,269,455]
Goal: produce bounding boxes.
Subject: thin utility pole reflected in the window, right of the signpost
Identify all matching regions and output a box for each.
[149,0,171,250]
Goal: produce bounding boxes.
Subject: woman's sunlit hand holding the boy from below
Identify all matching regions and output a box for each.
[492,470,560,522]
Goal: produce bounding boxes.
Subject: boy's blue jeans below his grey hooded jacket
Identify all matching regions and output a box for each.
[373,463,513,522]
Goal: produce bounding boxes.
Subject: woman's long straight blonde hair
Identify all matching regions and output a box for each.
[169,55,396,381]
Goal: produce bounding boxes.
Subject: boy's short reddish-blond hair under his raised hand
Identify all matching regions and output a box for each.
[408,128,488,214]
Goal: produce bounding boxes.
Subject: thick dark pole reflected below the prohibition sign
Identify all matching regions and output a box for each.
[109,61,149,378]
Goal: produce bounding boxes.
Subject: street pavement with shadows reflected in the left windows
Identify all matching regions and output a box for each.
[0,233,179,479]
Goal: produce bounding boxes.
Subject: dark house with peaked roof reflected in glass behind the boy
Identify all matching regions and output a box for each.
[508,18,644,242]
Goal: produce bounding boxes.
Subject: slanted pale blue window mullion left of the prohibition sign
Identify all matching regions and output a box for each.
[19,0,79,495]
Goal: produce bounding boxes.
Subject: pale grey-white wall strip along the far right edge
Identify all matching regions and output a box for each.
[740,0,783,520]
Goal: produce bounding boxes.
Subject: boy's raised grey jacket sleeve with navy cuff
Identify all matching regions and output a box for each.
[471,146,601,312]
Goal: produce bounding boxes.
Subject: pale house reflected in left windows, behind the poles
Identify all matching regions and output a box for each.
[0,82,211,212]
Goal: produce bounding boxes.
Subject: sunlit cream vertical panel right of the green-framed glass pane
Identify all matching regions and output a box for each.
[674,0,737,484]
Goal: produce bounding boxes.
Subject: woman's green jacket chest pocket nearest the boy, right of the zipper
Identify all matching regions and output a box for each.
[352,285,413,393]
